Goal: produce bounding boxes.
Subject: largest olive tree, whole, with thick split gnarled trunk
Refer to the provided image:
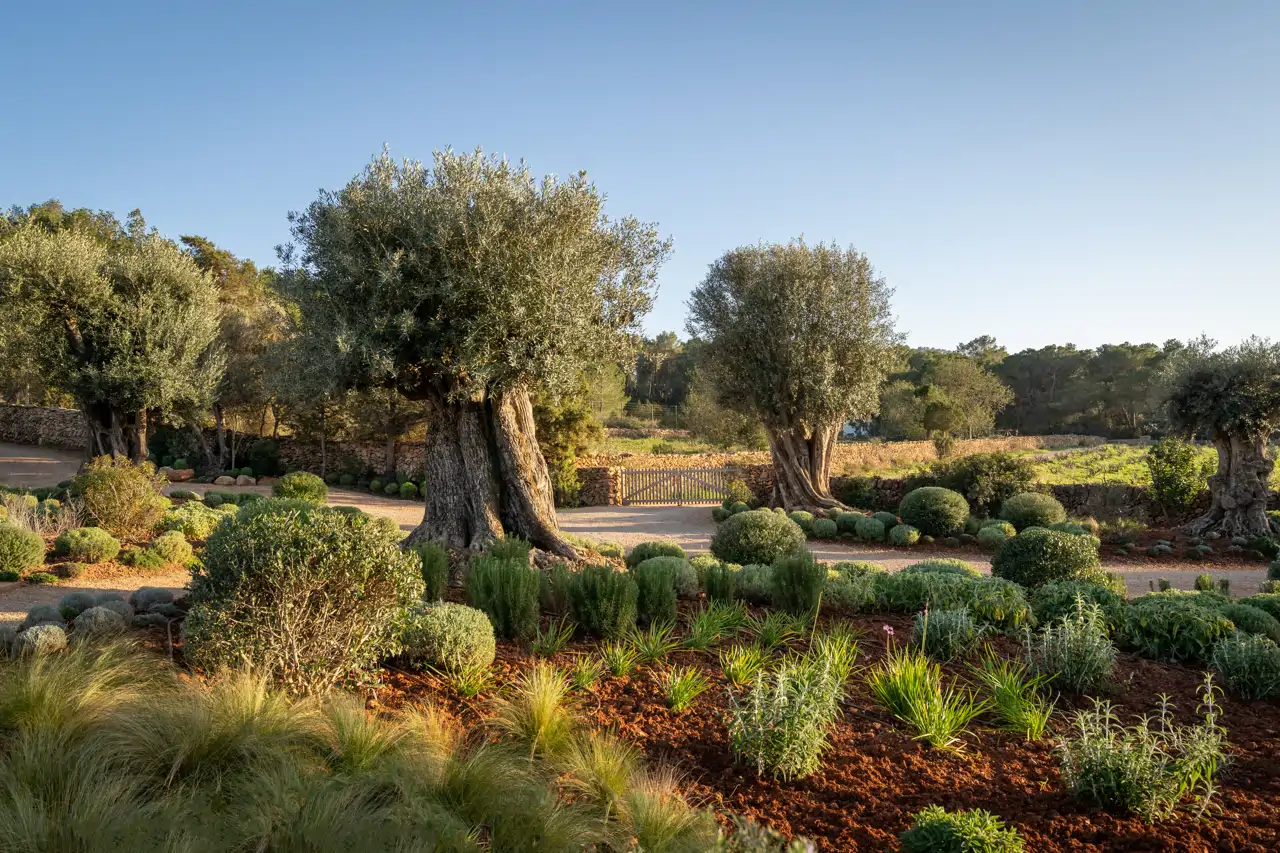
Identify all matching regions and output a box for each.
[273,151,669,556]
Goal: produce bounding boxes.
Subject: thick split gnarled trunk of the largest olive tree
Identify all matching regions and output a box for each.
[410,389,575,557]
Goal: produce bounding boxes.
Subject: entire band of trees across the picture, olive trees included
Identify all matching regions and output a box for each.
[0,151,1280,540]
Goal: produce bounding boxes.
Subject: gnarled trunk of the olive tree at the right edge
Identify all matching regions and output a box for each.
[1188,434,1274,537]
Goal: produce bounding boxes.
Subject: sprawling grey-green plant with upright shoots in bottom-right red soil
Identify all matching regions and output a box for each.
[1059,676,1226,821]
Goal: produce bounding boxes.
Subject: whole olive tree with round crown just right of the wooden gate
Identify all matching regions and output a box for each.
[689,241,896,510]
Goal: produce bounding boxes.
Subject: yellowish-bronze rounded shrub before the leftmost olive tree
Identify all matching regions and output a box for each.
[69,456,169,539]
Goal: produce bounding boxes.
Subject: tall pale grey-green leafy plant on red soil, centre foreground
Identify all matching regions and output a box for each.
[726,645,844,781]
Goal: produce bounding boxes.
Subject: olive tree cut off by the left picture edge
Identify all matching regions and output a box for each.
[0,213,223,461]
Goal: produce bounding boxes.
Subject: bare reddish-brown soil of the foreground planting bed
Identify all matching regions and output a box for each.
[371,607,1280,853]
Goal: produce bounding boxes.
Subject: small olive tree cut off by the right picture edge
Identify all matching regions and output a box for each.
[1169,338,1280,537]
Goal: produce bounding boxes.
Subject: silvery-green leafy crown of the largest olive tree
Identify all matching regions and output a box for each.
[279,150,671,401]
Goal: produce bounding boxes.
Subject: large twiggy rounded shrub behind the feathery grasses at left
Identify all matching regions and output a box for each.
[183,501,422,693]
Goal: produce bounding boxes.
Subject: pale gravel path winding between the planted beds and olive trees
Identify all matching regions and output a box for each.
[0,443,1266,624]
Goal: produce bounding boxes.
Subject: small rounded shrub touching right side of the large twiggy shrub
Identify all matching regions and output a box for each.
[399,602,498,672]
